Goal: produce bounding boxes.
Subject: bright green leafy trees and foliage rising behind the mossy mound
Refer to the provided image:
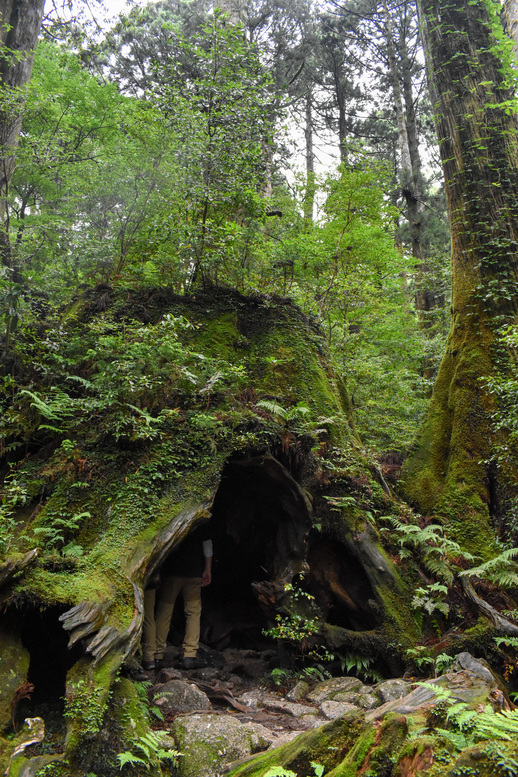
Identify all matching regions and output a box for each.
[0,24,446,458]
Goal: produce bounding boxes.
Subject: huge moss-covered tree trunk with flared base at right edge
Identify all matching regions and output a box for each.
[405,0,518,547]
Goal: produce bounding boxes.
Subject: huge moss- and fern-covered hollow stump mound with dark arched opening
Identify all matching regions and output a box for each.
[0,287,446,773]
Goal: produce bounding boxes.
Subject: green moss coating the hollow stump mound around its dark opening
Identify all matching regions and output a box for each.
[1,290,434,772]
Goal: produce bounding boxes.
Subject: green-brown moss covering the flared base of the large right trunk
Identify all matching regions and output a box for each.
[403,306,508,558]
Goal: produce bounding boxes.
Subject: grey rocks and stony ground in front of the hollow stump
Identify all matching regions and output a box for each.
[127,649,506,777]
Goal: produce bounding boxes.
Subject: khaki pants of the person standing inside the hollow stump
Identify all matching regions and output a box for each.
[146,577,205,661]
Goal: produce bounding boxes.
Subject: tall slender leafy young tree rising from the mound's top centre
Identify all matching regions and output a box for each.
[157,10,280,285]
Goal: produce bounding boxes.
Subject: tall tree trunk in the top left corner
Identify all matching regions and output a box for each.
[0,0,44,267]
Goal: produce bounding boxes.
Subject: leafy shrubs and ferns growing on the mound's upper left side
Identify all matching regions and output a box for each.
[4,314,248,452]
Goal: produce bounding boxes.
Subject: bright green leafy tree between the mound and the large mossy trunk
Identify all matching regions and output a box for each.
[290,158,428,450]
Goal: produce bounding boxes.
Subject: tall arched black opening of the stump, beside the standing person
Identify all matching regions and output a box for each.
[172,456,311,649]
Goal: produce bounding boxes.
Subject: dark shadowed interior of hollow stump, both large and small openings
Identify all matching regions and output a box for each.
[170,456,382,649]
